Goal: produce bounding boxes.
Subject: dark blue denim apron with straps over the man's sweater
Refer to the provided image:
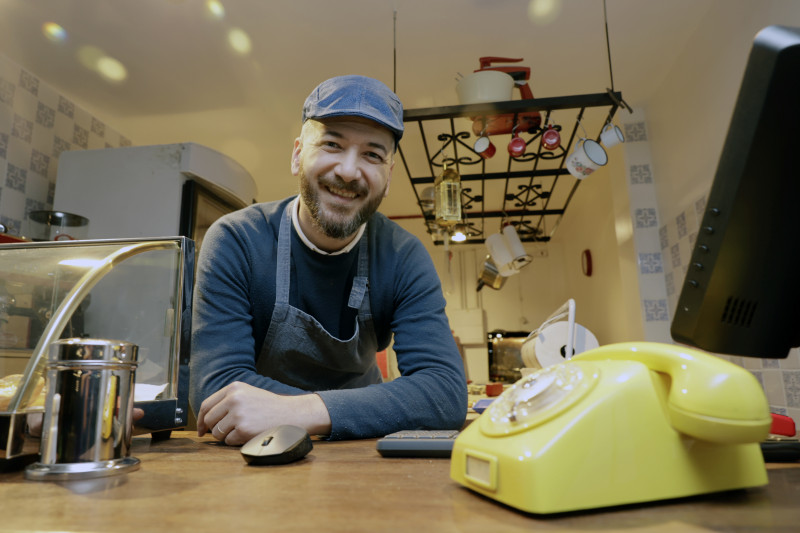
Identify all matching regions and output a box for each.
[256,203,382,391]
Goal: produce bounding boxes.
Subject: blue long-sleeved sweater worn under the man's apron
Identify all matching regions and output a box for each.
[190,198,467,439]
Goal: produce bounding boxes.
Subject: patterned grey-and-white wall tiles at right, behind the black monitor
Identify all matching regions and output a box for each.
[622,106,800,427]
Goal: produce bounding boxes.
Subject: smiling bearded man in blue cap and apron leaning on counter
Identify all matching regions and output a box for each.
[190,72,467,445]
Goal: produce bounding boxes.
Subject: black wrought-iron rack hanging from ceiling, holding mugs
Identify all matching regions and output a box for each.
[398,89,629,245]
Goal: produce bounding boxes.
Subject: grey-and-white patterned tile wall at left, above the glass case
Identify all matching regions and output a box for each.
[0,54,131,235]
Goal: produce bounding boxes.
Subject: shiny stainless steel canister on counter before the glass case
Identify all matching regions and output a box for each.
[25,338,139,480]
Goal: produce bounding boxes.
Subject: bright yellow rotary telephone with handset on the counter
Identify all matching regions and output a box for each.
[450,342,772,513]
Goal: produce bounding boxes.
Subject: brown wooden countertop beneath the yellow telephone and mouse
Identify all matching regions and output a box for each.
[0,432,800,533]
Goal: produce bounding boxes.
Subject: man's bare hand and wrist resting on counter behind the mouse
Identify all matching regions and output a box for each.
[197,382,331,445]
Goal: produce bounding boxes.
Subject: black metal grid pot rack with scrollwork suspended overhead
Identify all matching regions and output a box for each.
[399,89,630,245]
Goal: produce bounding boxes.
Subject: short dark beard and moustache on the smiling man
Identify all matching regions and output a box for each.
[299,165,388,240]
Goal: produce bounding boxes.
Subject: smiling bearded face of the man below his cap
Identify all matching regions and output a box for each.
[292,117,394,245]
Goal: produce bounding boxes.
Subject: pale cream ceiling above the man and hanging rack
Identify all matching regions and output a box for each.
[0,0,722,220]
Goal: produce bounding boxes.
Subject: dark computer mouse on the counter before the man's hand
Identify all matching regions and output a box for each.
[241,425,314,465]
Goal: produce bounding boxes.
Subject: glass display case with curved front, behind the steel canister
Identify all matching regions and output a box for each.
[0,237,195,462]
